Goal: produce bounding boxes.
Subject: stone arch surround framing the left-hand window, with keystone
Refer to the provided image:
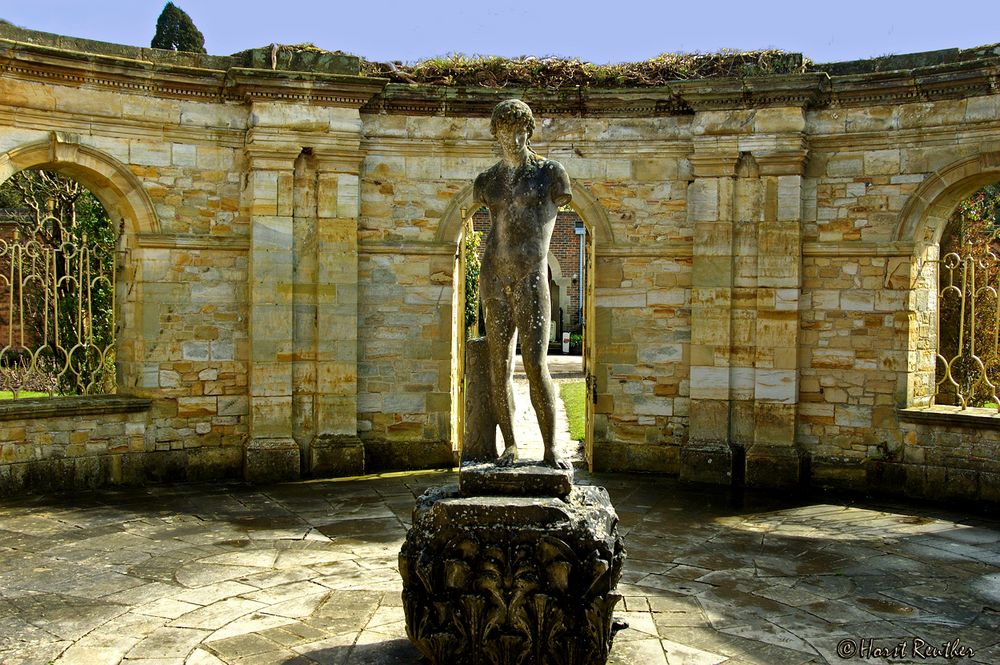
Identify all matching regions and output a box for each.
[0,132,160,400]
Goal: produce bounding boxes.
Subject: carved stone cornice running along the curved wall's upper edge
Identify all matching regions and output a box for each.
[0,33,1000,118]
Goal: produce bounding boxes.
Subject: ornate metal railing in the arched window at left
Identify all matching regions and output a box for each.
[0,206,117,399]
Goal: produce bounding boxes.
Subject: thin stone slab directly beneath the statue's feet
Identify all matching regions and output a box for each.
[458,462,573,498]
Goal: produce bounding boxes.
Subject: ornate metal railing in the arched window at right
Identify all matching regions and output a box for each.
[935,249,1000,412]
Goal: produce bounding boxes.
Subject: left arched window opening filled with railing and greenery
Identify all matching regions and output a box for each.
[0,169,119,399]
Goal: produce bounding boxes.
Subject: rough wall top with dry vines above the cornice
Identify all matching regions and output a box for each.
[0,19,1000,90]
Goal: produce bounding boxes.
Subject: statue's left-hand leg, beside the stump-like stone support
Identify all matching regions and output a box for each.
[483,298,517,464]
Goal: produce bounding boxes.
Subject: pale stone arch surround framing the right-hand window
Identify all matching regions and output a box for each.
[886,152,1000,407]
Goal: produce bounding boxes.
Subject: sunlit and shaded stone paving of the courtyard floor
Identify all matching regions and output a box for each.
[0,472,1000,665]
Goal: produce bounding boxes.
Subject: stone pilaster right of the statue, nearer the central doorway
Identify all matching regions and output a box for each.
[680,136,739,484]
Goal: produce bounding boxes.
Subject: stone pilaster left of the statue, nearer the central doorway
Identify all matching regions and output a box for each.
[309,154,364,476]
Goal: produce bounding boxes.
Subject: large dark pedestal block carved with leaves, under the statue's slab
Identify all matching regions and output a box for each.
[399,485,625,665]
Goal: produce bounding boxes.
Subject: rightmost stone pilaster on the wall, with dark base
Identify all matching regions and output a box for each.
[746,140,806,487]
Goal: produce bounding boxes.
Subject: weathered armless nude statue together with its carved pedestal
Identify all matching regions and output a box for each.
[399,100,625,665]
